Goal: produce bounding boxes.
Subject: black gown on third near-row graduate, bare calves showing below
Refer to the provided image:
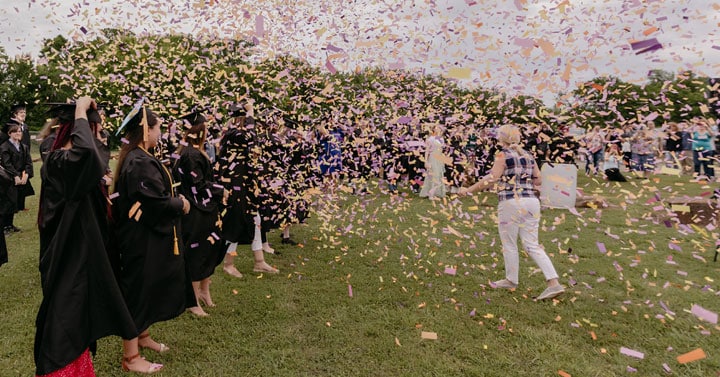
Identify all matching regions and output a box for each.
[173,146,225,281]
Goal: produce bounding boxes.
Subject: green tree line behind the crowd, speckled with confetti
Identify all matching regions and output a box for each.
[0,29,720,142]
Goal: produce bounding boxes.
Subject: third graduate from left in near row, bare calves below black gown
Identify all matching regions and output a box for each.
[173,112,228,316]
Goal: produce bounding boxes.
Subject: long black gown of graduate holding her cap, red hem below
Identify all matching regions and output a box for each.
[35,119,138,375]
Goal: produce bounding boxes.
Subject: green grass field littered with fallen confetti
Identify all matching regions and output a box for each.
[0,160,720,376]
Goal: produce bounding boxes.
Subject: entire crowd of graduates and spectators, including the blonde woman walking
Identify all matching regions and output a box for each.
[0,97,718,376]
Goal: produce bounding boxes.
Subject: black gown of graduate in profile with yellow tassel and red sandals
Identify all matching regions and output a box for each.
[113,148,196,332]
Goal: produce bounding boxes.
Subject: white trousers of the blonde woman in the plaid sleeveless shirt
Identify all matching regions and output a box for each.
[498,198,558,284]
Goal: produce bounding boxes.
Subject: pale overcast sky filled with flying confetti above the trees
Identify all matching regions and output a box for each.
[0,0,720,101]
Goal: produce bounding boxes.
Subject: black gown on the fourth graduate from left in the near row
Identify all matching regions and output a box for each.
[217,128,257,245]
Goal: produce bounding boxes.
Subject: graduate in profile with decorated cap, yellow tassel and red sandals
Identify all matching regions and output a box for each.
[113,101,197,373]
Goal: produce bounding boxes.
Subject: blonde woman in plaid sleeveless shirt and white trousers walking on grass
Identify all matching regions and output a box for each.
[459,125,565,300]
